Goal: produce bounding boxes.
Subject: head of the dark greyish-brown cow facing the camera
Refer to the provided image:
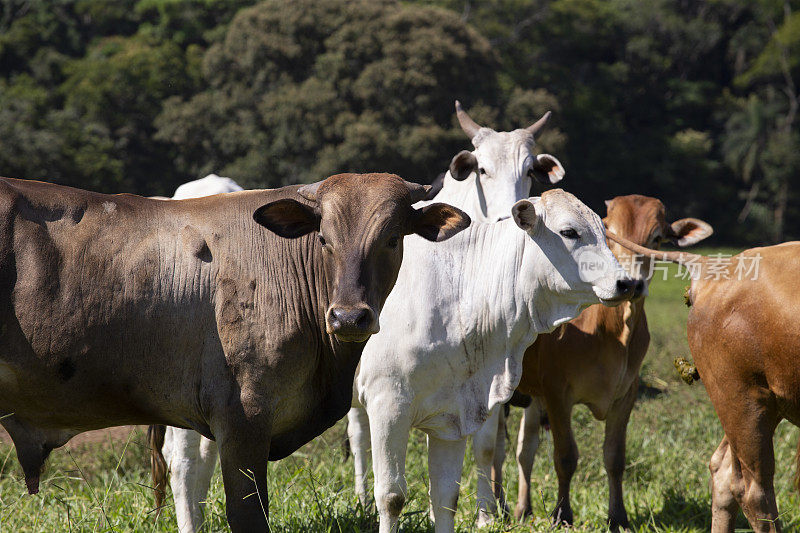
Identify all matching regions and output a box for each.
[253,174,470,342]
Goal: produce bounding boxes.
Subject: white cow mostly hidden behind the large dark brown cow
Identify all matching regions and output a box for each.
[156,174,243,533]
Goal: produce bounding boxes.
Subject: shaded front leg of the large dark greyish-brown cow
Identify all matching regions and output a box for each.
[217,427,269,533]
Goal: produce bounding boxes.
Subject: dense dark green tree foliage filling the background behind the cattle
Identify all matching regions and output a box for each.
[0,0,800,243]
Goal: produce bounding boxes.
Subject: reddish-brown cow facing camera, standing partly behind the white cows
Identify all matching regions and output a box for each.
[504,195,712,530]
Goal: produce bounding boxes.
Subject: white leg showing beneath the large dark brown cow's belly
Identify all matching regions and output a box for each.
[164,427,217,533]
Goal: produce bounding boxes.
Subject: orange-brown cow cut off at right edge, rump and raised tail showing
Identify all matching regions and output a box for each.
[609,235,800,532]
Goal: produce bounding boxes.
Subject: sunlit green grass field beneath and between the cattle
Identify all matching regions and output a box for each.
[0,249,800,532]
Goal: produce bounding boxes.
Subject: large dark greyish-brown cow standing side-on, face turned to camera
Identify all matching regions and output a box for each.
[0,174,469,532]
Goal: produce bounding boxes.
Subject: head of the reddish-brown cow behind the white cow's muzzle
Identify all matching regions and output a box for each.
[603,194,714,296]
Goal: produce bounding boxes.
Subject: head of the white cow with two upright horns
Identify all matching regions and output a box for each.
[450,101,564,222]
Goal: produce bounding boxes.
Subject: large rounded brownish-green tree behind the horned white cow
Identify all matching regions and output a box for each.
[156,0,506,186]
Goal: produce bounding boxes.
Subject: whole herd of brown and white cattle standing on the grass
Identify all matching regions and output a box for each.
[0,102,800,533]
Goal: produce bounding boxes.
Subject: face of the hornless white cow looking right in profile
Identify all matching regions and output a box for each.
[511,189,641,307]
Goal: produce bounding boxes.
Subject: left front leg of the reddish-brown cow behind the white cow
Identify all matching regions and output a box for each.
[545,397,578,525]
